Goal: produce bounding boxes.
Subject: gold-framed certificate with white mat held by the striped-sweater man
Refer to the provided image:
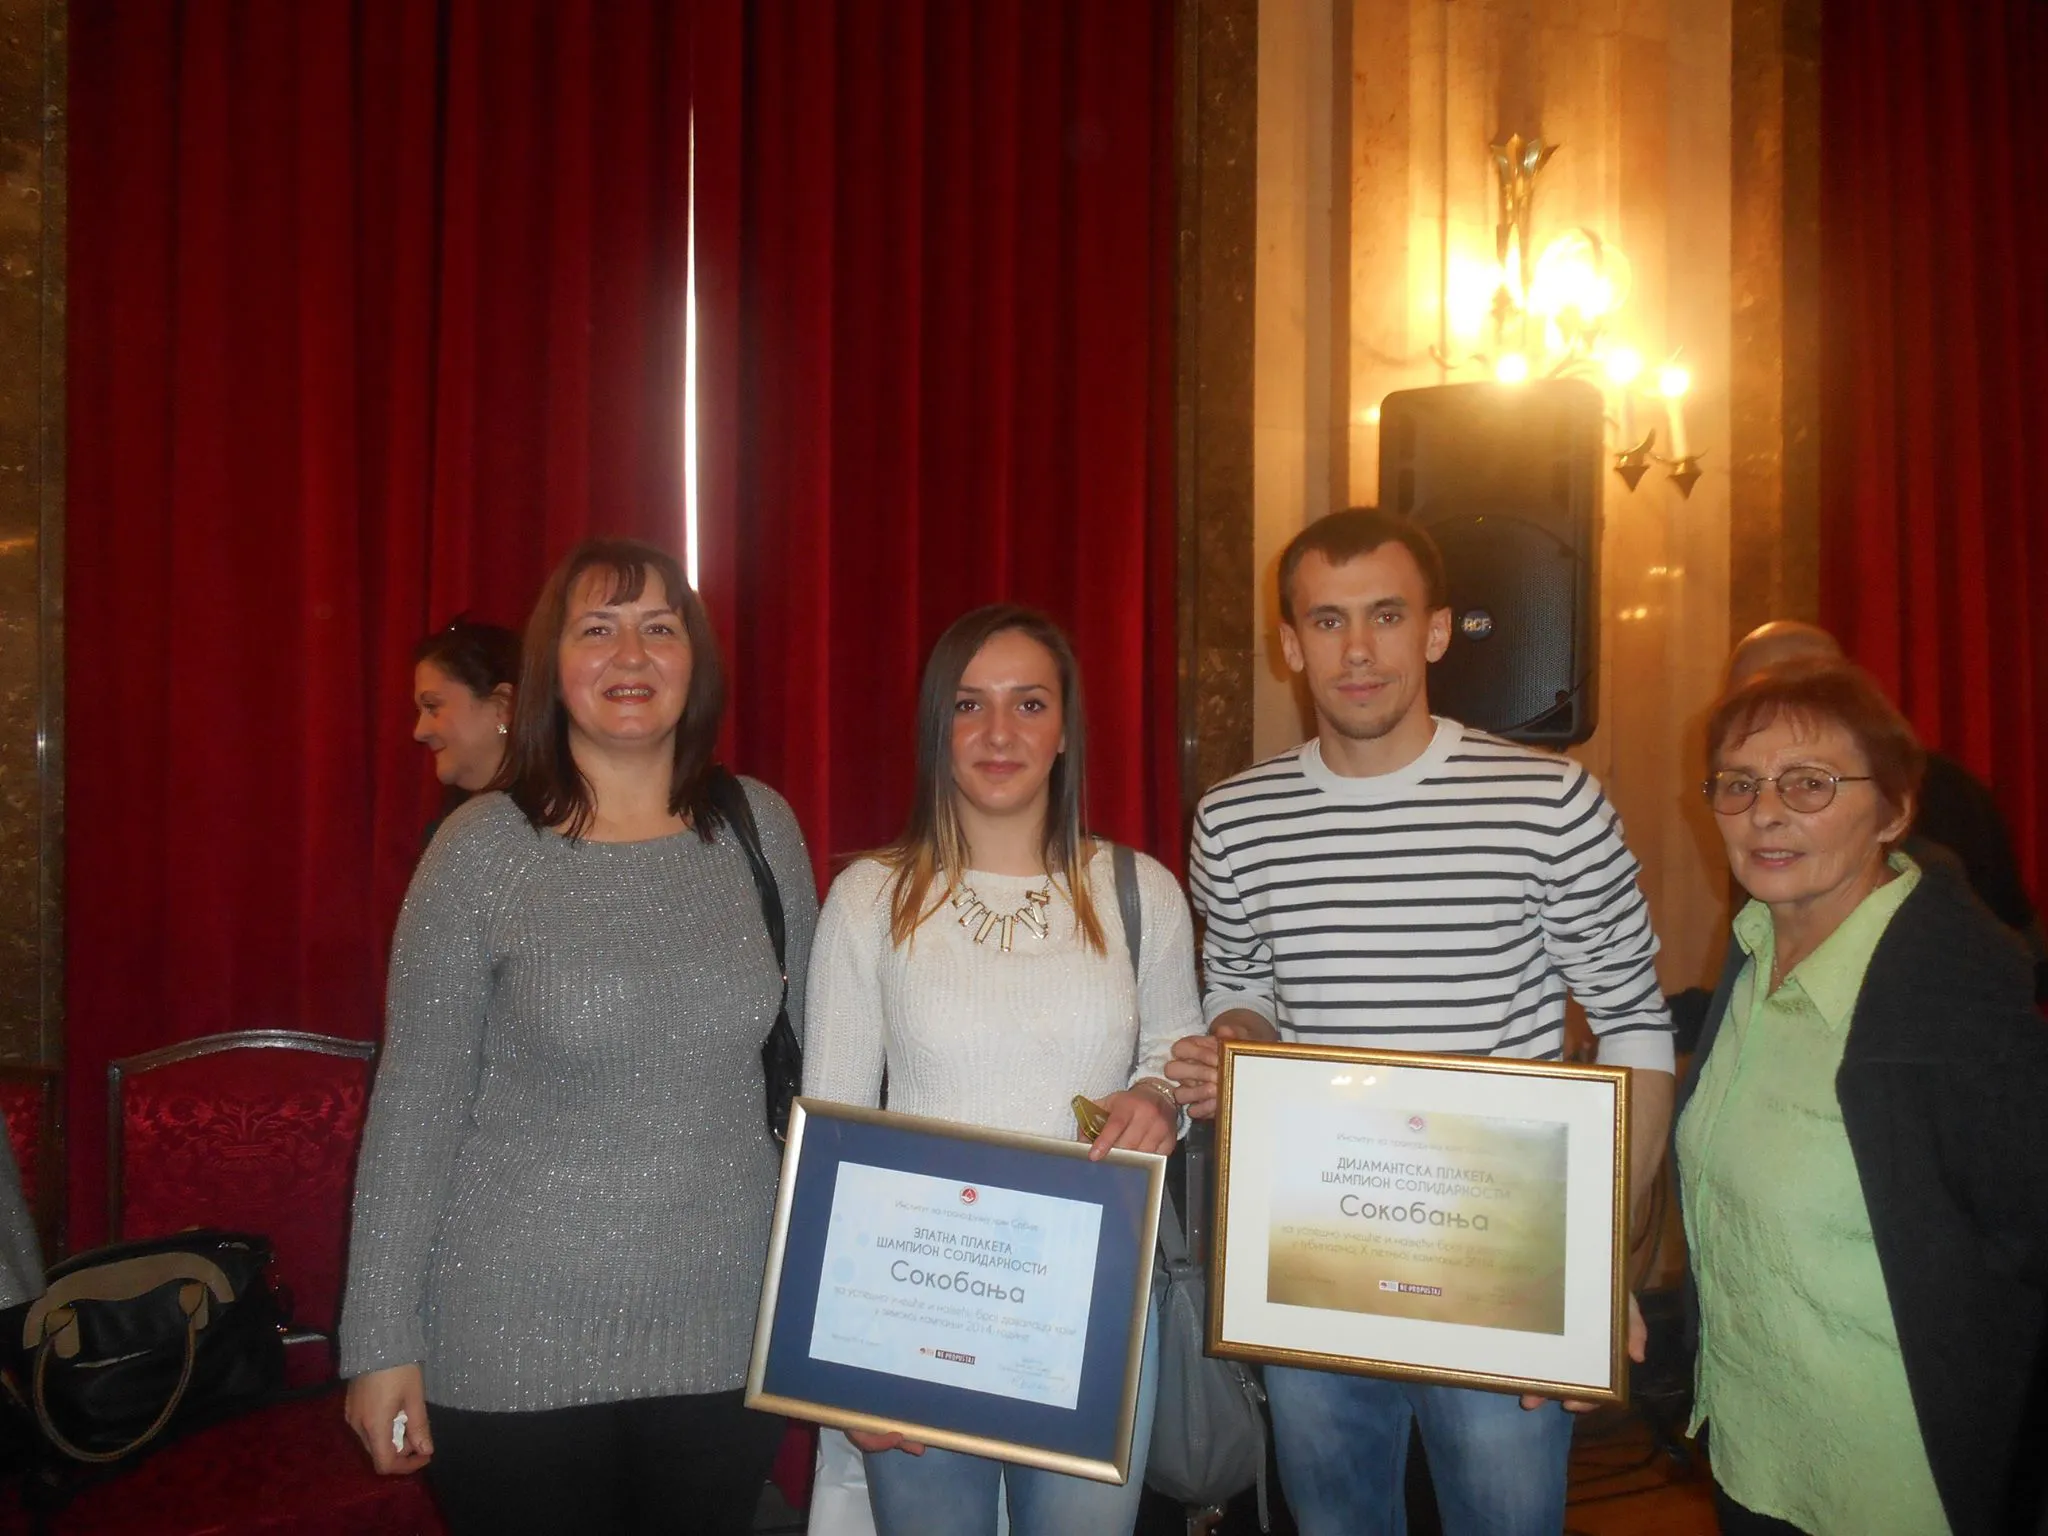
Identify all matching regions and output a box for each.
[1208,1040,1628,1403]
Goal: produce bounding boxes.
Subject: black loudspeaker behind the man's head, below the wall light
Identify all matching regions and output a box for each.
[1380,379,1606,748]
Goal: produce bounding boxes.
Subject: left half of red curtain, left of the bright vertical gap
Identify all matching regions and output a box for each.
[66,0,739,1241]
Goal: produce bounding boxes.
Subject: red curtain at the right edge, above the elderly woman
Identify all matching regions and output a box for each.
[1821,0,2048,897]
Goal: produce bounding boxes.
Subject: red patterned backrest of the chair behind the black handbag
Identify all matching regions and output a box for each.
[106,1030,377,1331]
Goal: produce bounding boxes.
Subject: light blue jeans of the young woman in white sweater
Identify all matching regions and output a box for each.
[866,1296,1159,1536]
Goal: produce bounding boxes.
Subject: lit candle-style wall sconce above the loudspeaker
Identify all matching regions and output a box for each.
[1432,133,1700,498]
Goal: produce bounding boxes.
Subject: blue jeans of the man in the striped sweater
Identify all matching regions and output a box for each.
[1266,1366,1571,1536]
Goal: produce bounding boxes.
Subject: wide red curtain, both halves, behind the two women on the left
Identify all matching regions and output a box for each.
[66,0,1182,1241]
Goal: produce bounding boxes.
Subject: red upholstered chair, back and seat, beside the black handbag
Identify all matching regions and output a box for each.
[51,1030,444,1536]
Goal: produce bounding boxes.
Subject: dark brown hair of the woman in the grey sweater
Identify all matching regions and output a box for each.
[492,539,725,842]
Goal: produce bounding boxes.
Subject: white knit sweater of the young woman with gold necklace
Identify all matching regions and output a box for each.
[803,848,1202,1137]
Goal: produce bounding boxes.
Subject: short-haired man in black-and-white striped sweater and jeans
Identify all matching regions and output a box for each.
[1167,508,1671,1536]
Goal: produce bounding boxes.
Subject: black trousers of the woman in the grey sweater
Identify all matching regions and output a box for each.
[426,1393,782,1536]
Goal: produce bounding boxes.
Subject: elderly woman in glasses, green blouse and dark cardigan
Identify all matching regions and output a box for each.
[1677,662,2048,1536]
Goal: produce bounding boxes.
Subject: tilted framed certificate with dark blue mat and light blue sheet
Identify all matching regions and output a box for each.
[745,1098,1165,1483]
